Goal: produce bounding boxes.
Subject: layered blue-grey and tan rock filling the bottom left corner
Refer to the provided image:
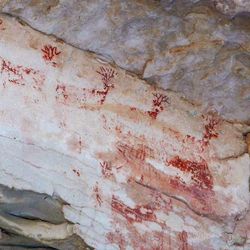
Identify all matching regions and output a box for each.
[0,185,88,250]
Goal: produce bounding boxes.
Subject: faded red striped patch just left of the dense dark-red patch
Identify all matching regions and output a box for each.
[117,143,154,161]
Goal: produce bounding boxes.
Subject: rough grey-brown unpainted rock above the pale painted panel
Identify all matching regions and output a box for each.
[2,0,250,123]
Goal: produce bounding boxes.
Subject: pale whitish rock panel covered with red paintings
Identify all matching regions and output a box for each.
[0,15,250,250]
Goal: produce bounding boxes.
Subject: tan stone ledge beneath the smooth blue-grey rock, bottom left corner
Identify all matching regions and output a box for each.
[0,213,90,250]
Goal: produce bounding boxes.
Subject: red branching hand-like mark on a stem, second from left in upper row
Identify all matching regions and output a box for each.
[95,67,117,104]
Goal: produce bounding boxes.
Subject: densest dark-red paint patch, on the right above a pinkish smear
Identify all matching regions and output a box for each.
[167,156,213,189]
